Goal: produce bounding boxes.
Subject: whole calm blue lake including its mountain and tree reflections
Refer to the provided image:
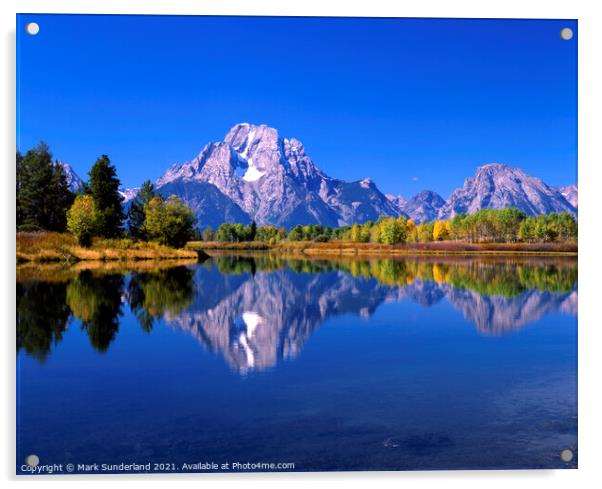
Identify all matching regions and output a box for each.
[17,256,577,471]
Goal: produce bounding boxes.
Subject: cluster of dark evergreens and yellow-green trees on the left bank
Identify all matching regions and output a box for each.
[16,142,196,247]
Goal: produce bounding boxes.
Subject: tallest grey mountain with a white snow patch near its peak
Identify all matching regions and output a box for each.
[157,123,403,228]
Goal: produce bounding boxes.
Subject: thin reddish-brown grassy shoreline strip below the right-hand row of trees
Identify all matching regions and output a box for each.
[186,241,578,256]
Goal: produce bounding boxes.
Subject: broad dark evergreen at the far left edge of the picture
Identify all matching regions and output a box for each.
[17,143,74,231]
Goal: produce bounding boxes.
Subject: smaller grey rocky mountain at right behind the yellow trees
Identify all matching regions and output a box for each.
[437,163,577,219]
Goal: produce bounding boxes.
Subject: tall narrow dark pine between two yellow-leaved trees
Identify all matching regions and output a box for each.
[88,155,125,238]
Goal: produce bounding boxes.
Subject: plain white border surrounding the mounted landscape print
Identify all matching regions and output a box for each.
[0,0,602,489]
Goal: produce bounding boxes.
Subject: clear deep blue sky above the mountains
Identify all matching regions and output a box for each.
[17,14,577,197]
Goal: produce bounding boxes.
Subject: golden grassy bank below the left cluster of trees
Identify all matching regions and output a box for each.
[16,232,199,263]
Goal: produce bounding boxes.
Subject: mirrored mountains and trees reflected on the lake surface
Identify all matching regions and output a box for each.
[17,255,577,373]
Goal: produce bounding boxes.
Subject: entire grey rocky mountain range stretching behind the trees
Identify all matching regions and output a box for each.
[61,123,578,228]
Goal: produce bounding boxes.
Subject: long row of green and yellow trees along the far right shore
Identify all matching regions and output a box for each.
[202,207,577,244]
